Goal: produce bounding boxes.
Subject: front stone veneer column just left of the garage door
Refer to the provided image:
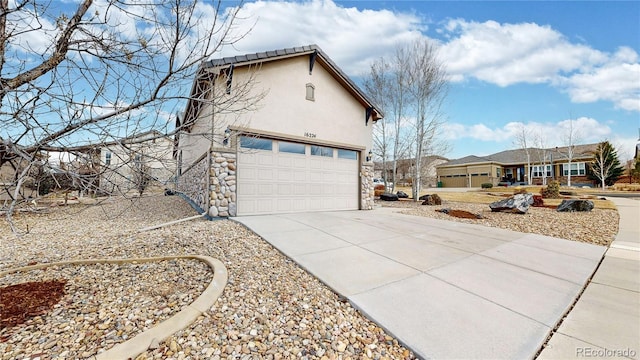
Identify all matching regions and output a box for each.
[209,149,237,216]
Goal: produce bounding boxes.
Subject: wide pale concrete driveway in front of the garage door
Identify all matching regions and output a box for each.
[234,208,606,359]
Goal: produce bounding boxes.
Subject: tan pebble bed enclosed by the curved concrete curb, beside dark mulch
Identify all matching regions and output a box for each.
[0,259,213,359]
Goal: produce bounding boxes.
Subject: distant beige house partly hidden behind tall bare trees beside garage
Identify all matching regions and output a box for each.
[375,155,449,187]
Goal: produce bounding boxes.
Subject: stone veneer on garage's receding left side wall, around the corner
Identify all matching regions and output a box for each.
[177,152,209,211]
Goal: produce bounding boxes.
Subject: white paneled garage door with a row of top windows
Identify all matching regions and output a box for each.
[236,137,359,215]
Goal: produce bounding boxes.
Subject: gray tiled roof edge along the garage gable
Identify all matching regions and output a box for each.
[201,44,383,118]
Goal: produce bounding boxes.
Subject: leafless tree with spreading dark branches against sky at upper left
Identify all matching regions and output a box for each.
[0,0,250,229]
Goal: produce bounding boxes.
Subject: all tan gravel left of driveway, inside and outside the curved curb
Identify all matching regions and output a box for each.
[0,195,414,359]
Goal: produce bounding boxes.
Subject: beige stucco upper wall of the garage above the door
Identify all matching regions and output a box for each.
[180,55,373,167]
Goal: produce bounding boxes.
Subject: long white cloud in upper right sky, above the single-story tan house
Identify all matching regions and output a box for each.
[441,19,606,86]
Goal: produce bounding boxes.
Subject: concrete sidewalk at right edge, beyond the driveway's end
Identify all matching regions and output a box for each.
[539,197,640,359]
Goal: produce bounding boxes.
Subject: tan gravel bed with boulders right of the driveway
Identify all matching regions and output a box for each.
[376,200,619,246]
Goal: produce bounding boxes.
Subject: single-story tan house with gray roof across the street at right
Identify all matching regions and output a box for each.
[437,144,598,187]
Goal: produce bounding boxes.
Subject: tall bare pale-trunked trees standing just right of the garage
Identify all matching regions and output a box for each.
[365,40,448,201]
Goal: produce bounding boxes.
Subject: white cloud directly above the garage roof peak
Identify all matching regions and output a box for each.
[216,0,424,75]
